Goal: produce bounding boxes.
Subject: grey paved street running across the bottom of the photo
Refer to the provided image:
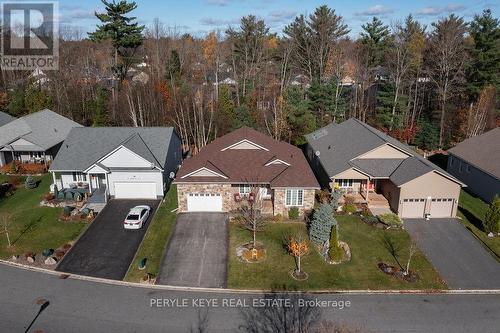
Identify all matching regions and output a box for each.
[0,264,500,333]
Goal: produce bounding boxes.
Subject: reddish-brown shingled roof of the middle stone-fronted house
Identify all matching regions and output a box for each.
[175,127,319,188]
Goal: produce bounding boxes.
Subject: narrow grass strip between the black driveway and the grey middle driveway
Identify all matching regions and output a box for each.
[124,185,177,282]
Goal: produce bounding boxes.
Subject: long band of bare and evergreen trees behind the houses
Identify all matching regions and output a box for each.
[0,1,500,152]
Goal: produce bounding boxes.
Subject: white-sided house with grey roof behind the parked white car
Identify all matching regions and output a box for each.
[49,127,182,208]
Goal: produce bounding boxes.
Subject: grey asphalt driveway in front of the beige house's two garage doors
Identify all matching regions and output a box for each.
[405,218,500,289]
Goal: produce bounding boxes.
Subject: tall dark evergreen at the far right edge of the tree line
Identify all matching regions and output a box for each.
[467,9,500,99]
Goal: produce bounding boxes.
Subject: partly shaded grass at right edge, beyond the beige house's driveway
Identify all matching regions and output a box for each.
[458,190,500,261]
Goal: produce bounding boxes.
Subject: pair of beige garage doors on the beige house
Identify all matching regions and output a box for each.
[401,198,454,218]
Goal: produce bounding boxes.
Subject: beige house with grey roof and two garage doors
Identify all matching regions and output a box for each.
[306,118,465,218]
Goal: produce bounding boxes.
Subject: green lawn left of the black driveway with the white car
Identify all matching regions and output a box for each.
[0,174,86,259]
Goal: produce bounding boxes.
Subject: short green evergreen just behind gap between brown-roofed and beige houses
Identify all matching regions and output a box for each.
[284,87,316,145]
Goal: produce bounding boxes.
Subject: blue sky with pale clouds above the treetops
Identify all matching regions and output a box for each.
[59,0,500,37]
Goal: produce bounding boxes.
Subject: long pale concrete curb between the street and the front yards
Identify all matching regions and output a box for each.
[0,259,500,295]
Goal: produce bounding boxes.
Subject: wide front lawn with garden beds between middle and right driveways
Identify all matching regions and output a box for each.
[228,216,446,290]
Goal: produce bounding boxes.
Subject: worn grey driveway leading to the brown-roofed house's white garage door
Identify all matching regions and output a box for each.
[157,213,229,288]
